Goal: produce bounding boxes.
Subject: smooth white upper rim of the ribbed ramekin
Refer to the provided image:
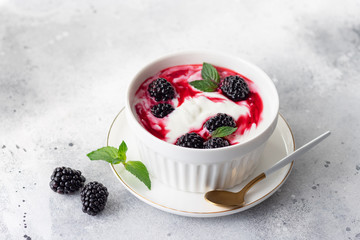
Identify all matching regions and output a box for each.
[125,50,279,153]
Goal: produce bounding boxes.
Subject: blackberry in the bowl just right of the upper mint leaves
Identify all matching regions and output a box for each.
[221,76,250,102]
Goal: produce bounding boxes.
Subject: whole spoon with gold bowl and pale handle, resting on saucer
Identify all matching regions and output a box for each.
[204,131,330,207]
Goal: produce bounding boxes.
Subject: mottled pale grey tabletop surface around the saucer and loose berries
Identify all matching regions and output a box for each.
[0,0,360,239]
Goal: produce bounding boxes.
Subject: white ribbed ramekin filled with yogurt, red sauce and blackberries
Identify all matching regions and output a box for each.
[126,52,279,192]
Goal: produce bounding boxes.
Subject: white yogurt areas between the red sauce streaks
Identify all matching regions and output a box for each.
[134,64,262,144]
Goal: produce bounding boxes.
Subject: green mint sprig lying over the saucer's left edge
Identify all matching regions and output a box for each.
[86,141,151,190]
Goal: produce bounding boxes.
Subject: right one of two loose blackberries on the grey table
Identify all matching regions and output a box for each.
[81,182,109,216]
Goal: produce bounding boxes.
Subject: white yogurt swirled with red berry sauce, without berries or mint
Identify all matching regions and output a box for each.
[133,64,263,145]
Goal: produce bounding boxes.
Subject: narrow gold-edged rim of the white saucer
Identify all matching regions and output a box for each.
[106,107,296,217]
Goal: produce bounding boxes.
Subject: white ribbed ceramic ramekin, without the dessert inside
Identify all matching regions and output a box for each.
[125,51,279,192]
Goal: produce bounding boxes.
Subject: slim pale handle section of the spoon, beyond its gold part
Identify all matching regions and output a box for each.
[264,131,330,176]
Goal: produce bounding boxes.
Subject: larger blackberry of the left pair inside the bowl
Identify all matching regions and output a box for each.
[148,78,175,102]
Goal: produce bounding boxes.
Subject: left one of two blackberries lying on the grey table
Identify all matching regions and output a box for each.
[50,167,85,194]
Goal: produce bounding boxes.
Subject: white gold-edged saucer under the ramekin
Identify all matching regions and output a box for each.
[107,110,295,217]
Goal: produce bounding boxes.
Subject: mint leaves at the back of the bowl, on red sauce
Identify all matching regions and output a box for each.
[189,62,220,92]
